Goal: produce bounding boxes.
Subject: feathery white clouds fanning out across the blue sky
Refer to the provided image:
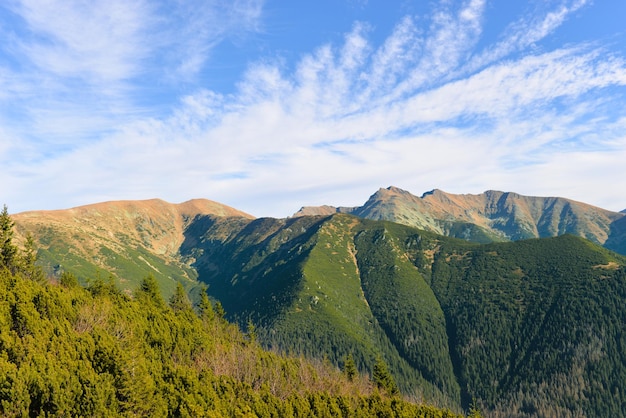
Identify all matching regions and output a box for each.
[0,0,626,216]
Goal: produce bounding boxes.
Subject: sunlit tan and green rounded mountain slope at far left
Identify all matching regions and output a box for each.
[13,199,252,295]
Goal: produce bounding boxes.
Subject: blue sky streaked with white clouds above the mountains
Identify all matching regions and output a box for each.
[0,0,626,217]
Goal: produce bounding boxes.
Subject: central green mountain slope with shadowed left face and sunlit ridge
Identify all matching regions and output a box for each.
[184,215,460,405]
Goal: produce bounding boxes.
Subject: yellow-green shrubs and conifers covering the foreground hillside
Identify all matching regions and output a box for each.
[0,208,457,417]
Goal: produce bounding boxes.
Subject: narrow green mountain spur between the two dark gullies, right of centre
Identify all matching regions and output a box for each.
[355,223,460,402]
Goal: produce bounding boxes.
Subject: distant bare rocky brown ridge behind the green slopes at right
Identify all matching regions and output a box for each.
[294,187,626,254]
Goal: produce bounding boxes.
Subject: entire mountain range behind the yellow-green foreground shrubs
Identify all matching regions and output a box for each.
[9,187,626,416]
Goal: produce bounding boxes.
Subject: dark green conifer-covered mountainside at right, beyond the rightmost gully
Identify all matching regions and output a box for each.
[432,236,626,416]
